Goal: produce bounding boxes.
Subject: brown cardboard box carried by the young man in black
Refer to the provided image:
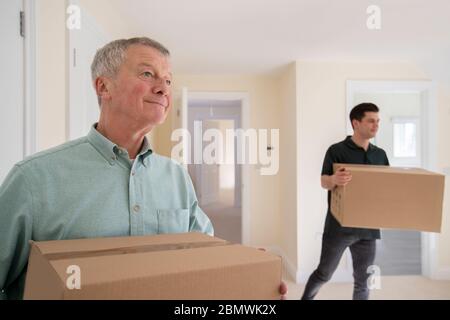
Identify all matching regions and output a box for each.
[331,163,445,232]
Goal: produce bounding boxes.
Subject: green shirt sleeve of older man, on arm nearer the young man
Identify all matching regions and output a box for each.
[183,169,214,236]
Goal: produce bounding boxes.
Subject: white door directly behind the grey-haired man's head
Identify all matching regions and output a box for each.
[68,0,108,140]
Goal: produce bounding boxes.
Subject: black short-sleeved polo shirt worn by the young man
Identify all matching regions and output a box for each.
[322,136,389,239]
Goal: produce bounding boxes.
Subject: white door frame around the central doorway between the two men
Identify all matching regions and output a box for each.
[181,87,251,245]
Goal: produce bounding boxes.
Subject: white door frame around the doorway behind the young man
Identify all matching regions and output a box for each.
[345,80,439,279]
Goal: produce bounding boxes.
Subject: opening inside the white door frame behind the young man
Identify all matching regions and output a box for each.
[353,92,423,275]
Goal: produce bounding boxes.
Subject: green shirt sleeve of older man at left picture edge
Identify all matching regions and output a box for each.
[0,166,33,299]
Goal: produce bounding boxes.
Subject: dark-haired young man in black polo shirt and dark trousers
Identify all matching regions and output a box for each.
[302,103,389,300]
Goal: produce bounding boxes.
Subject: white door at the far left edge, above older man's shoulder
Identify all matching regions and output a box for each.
[0,0,24,184]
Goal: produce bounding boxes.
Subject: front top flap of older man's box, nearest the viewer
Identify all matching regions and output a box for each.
[50,244,281,287]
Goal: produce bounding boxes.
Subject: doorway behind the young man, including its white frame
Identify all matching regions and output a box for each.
[347,81,434,276]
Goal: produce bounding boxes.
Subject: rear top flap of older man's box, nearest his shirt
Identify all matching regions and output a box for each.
[31,232,226,255]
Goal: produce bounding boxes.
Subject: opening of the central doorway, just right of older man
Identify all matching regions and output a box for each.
[187,99,243,243]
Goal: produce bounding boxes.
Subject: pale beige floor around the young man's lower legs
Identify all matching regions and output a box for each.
[283,275,450,300]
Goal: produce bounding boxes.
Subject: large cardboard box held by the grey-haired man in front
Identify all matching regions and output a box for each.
[24,233,281,300]
